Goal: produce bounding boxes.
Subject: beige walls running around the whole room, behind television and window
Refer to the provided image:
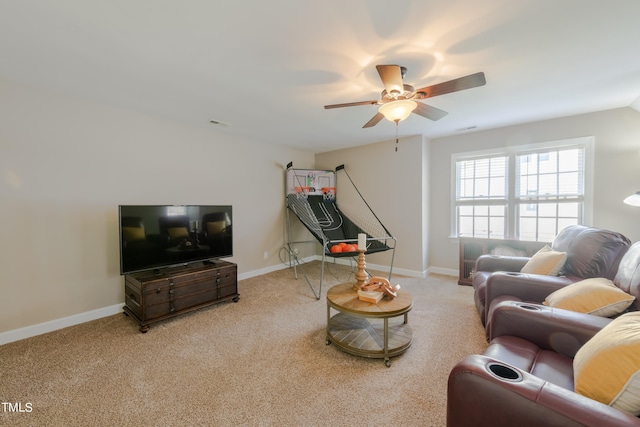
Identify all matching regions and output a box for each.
[5,72,640,341]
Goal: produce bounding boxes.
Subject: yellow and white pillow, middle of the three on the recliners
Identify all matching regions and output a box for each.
[543,277,640,318]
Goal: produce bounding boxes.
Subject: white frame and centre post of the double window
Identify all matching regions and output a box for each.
[449,136,595,240]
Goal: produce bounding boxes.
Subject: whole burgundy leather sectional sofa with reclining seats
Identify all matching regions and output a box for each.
[447,226,640,427]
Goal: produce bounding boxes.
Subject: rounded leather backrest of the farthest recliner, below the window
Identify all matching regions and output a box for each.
[552,225,631,280]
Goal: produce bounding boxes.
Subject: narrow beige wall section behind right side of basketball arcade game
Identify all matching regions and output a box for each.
[315,135,428,276]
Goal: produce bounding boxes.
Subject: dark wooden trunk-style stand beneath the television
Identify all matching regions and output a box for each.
[123,261,240,333]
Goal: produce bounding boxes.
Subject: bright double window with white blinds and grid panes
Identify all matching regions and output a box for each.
[452,138,593,241]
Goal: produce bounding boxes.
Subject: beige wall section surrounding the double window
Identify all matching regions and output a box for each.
[429,108,640,271]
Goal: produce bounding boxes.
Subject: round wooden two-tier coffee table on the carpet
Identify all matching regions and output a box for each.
[326,282,413,367]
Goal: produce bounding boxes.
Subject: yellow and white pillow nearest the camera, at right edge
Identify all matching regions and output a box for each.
[573,311,640,416]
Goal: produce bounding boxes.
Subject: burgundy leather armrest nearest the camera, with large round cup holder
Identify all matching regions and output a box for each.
[447,355,640,427]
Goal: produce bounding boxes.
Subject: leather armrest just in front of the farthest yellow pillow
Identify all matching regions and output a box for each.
[485,271,574,309]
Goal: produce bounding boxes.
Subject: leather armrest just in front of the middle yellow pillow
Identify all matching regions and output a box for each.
[487,301,611,358]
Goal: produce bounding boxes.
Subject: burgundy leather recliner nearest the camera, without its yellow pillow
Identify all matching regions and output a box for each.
[447,242,640,427]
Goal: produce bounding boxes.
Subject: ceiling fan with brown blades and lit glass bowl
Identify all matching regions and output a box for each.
[324,65,486,128]
